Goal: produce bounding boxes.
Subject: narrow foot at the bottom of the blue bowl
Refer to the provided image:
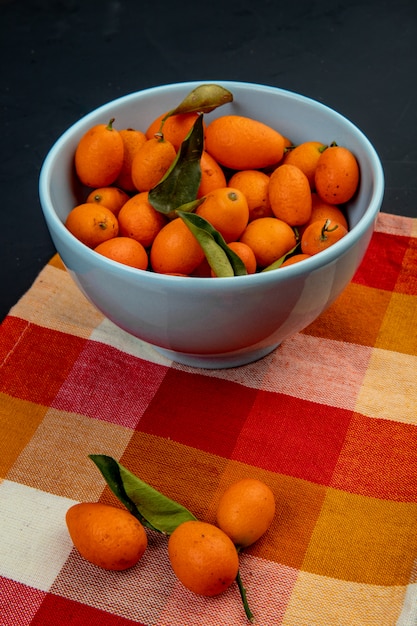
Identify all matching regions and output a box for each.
[153,343,280,370]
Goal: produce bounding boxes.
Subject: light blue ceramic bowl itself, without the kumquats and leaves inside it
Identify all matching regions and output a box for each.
[40,80,384,368]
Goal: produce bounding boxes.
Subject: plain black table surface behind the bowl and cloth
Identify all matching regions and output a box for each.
[0,0,417,320]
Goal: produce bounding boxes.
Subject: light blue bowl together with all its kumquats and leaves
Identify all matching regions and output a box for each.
[40,81,384,368]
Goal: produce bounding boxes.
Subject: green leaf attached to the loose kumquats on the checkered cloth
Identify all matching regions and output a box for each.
[89,454,197,535]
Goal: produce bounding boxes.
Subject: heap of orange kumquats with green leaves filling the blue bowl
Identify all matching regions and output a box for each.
[65,85,360,278]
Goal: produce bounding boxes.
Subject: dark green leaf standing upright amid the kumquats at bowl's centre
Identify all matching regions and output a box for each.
[148,115,204,215]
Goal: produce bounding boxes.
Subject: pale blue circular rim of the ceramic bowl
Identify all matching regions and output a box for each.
[39,79,384,290]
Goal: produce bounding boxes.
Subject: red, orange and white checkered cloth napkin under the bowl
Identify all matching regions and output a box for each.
[0,214,417,626]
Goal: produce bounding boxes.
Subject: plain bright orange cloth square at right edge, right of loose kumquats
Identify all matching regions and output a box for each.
[302,488,417,585]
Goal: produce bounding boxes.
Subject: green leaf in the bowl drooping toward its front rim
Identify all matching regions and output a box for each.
[176,210,247,278]
